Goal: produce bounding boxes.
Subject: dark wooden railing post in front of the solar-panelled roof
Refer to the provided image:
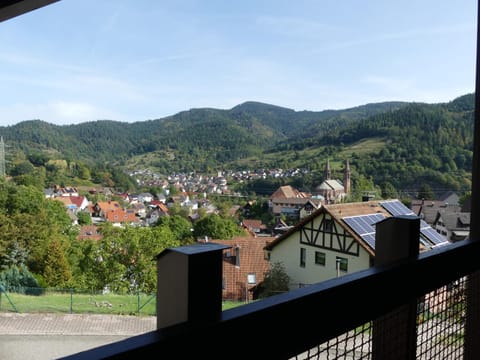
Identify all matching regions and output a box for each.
[372,216,420,360]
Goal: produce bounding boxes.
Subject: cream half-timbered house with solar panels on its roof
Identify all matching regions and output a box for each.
[265,199,448,288]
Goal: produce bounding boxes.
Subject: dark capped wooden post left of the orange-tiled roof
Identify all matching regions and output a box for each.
[157,243,230,329]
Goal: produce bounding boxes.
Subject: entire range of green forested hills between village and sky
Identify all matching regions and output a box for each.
[0,94,474,194]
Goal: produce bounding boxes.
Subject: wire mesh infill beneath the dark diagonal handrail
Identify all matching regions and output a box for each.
[293,277,467,360]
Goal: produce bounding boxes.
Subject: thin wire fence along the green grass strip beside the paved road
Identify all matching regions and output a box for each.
[0,287,156,316]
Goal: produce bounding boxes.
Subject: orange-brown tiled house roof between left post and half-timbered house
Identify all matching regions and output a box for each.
[209,236,274,301]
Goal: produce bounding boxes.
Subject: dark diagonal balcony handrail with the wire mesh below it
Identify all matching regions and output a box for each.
[62,229,480,360]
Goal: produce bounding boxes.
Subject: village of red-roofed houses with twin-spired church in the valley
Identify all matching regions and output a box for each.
[45,161,470,301]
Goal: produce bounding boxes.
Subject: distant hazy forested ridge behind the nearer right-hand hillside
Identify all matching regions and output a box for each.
[0,102,407,166]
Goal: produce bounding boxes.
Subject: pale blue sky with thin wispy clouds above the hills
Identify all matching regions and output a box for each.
[0,0,477,126]
